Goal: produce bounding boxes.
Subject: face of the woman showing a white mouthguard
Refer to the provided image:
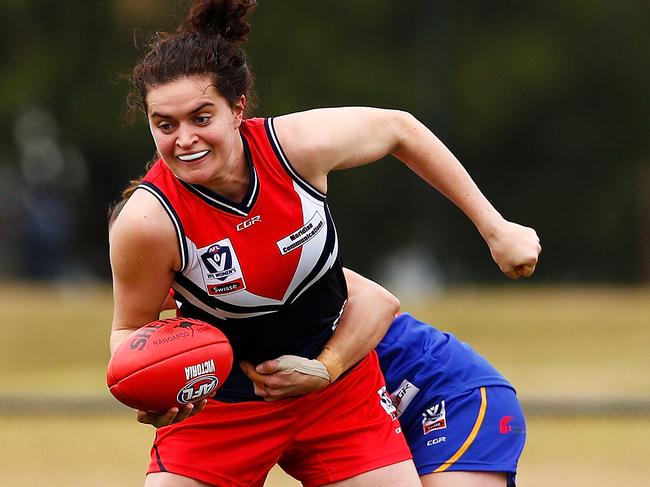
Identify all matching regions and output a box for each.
[147,76,245,191]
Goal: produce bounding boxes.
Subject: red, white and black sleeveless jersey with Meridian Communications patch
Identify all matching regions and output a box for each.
[139,118,347,400]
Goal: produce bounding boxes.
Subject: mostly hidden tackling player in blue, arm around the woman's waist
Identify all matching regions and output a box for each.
[242,269,526,487]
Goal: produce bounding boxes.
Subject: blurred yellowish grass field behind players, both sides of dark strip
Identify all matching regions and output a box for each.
[0,285,650,487]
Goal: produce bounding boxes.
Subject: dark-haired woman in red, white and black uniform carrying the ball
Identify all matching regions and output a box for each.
[110,0,539,486]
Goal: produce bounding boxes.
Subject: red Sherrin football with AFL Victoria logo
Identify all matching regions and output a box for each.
[106,318,233,412]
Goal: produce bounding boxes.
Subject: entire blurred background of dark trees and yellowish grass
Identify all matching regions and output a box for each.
[0,0,650,486]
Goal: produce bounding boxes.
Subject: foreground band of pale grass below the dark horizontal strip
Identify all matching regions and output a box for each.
[0,414,650,487]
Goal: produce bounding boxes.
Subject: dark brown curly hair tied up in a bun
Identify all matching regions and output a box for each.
[127,0,256,119]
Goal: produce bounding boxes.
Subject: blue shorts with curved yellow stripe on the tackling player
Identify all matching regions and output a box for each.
[400,386,526,485]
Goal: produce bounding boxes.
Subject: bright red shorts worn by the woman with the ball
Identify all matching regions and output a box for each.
[147,351,411,486]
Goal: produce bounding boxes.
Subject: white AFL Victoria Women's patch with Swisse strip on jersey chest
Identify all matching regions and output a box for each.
[197,238,246,296]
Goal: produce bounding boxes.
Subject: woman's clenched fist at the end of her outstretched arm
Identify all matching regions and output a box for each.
[486,220,542,279]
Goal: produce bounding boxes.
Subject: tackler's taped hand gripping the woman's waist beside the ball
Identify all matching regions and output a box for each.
[239,355,330,401]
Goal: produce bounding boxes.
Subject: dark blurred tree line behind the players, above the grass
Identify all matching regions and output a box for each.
[0,0,650,283]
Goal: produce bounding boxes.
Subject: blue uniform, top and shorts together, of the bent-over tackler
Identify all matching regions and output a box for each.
[377,313,526,485]
